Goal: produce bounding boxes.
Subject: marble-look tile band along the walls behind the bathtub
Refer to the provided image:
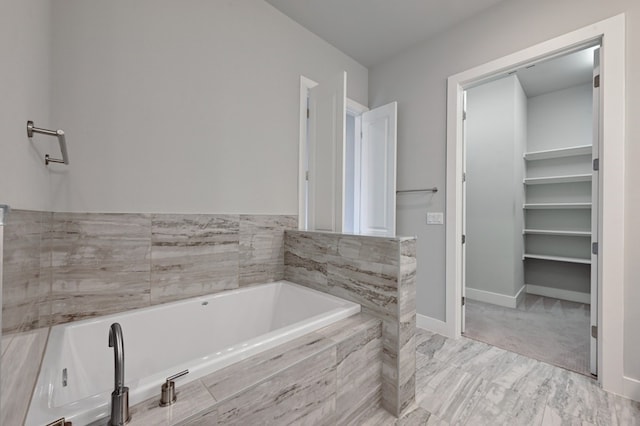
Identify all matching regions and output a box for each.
[2,210,297,333]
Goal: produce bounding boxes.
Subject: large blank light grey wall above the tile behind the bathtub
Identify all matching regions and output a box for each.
[51,0,367,214]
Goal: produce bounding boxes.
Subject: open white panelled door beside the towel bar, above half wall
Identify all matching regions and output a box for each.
[359,102,398,237]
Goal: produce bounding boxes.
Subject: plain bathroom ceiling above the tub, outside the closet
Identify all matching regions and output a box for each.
[265,0,503,68]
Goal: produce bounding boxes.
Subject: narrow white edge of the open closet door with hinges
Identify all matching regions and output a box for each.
[589,48,600,375]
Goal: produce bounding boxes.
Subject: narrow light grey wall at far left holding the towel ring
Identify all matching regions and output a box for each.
[0,0,51,209]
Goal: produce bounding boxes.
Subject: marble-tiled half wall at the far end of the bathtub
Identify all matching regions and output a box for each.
[285,231,416,416]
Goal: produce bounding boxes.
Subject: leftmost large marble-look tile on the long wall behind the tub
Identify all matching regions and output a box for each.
[49,213,151,324]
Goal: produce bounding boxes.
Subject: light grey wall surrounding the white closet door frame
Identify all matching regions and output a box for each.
[369,0,640,380]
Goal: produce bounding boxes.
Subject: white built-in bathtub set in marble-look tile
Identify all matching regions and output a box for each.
[26,281,360,426]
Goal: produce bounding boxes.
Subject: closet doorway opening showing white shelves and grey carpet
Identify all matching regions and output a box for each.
[463,46,599,376]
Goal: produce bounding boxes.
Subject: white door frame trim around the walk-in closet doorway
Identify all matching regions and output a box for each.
[446,14,629,394]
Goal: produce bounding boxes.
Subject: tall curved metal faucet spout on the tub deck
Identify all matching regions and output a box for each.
[109,322,131,426]
